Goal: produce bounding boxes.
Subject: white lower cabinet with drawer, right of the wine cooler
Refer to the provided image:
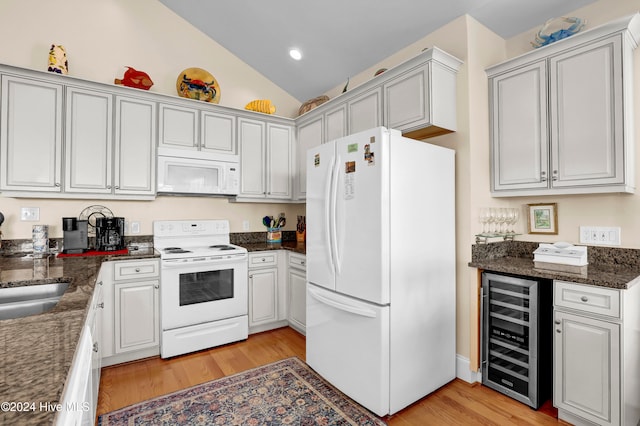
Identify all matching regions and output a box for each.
[553,281,640,426]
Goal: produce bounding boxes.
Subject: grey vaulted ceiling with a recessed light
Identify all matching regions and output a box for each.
[160,0,595,101]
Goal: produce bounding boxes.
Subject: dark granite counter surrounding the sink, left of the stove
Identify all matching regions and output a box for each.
[0,248,159,425]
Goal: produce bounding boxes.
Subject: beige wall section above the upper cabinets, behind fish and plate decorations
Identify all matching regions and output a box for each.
[0,0,300,117]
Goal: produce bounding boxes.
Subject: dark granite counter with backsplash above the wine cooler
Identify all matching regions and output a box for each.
[469,241,640,289]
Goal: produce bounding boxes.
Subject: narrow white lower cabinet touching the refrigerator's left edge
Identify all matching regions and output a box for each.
[288,253,307,334]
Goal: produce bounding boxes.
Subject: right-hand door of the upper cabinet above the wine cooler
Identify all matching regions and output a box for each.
[549,35,634,188]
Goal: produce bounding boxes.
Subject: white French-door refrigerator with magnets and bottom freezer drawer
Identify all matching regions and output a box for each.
[306,127,456,416]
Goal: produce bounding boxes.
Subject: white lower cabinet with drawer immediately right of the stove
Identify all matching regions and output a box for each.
[249,250,287,333]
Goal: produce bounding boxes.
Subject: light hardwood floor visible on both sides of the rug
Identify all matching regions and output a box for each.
[98,327,566,426]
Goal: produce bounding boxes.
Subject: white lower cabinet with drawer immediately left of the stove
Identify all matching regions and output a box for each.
[102,259,160,365]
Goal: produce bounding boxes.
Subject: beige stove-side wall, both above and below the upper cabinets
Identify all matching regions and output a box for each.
[0,0,304,239]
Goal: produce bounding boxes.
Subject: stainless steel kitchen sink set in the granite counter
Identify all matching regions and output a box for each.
[0,282,69,320]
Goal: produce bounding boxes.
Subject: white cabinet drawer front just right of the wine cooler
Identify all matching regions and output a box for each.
[553,281,620,318]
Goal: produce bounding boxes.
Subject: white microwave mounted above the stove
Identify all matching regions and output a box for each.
[158,148,240,195]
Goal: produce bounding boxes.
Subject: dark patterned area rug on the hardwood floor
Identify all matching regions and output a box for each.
[98,357,386,426]
